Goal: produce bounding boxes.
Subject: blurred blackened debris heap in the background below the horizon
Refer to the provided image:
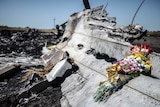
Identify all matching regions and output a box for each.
[0,29,62,58]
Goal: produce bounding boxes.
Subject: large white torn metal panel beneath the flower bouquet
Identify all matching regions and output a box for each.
[61,7,160,107]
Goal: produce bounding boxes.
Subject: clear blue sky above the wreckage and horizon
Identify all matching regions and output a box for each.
[0,0,160,31]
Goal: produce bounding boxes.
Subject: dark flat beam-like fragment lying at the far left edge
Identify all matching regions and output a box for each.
[0,64,20,80]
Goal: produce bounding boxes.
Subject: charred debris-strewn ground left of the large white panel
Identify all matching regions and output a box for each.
[0,25,78,107]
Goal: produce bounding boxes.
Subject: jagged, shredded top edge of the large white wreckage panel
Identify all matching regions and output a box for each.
[85,5,145,41]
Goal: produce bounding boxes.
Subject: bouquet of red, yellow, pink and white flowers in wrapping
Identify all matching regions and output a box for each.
[94,44,152,102]
